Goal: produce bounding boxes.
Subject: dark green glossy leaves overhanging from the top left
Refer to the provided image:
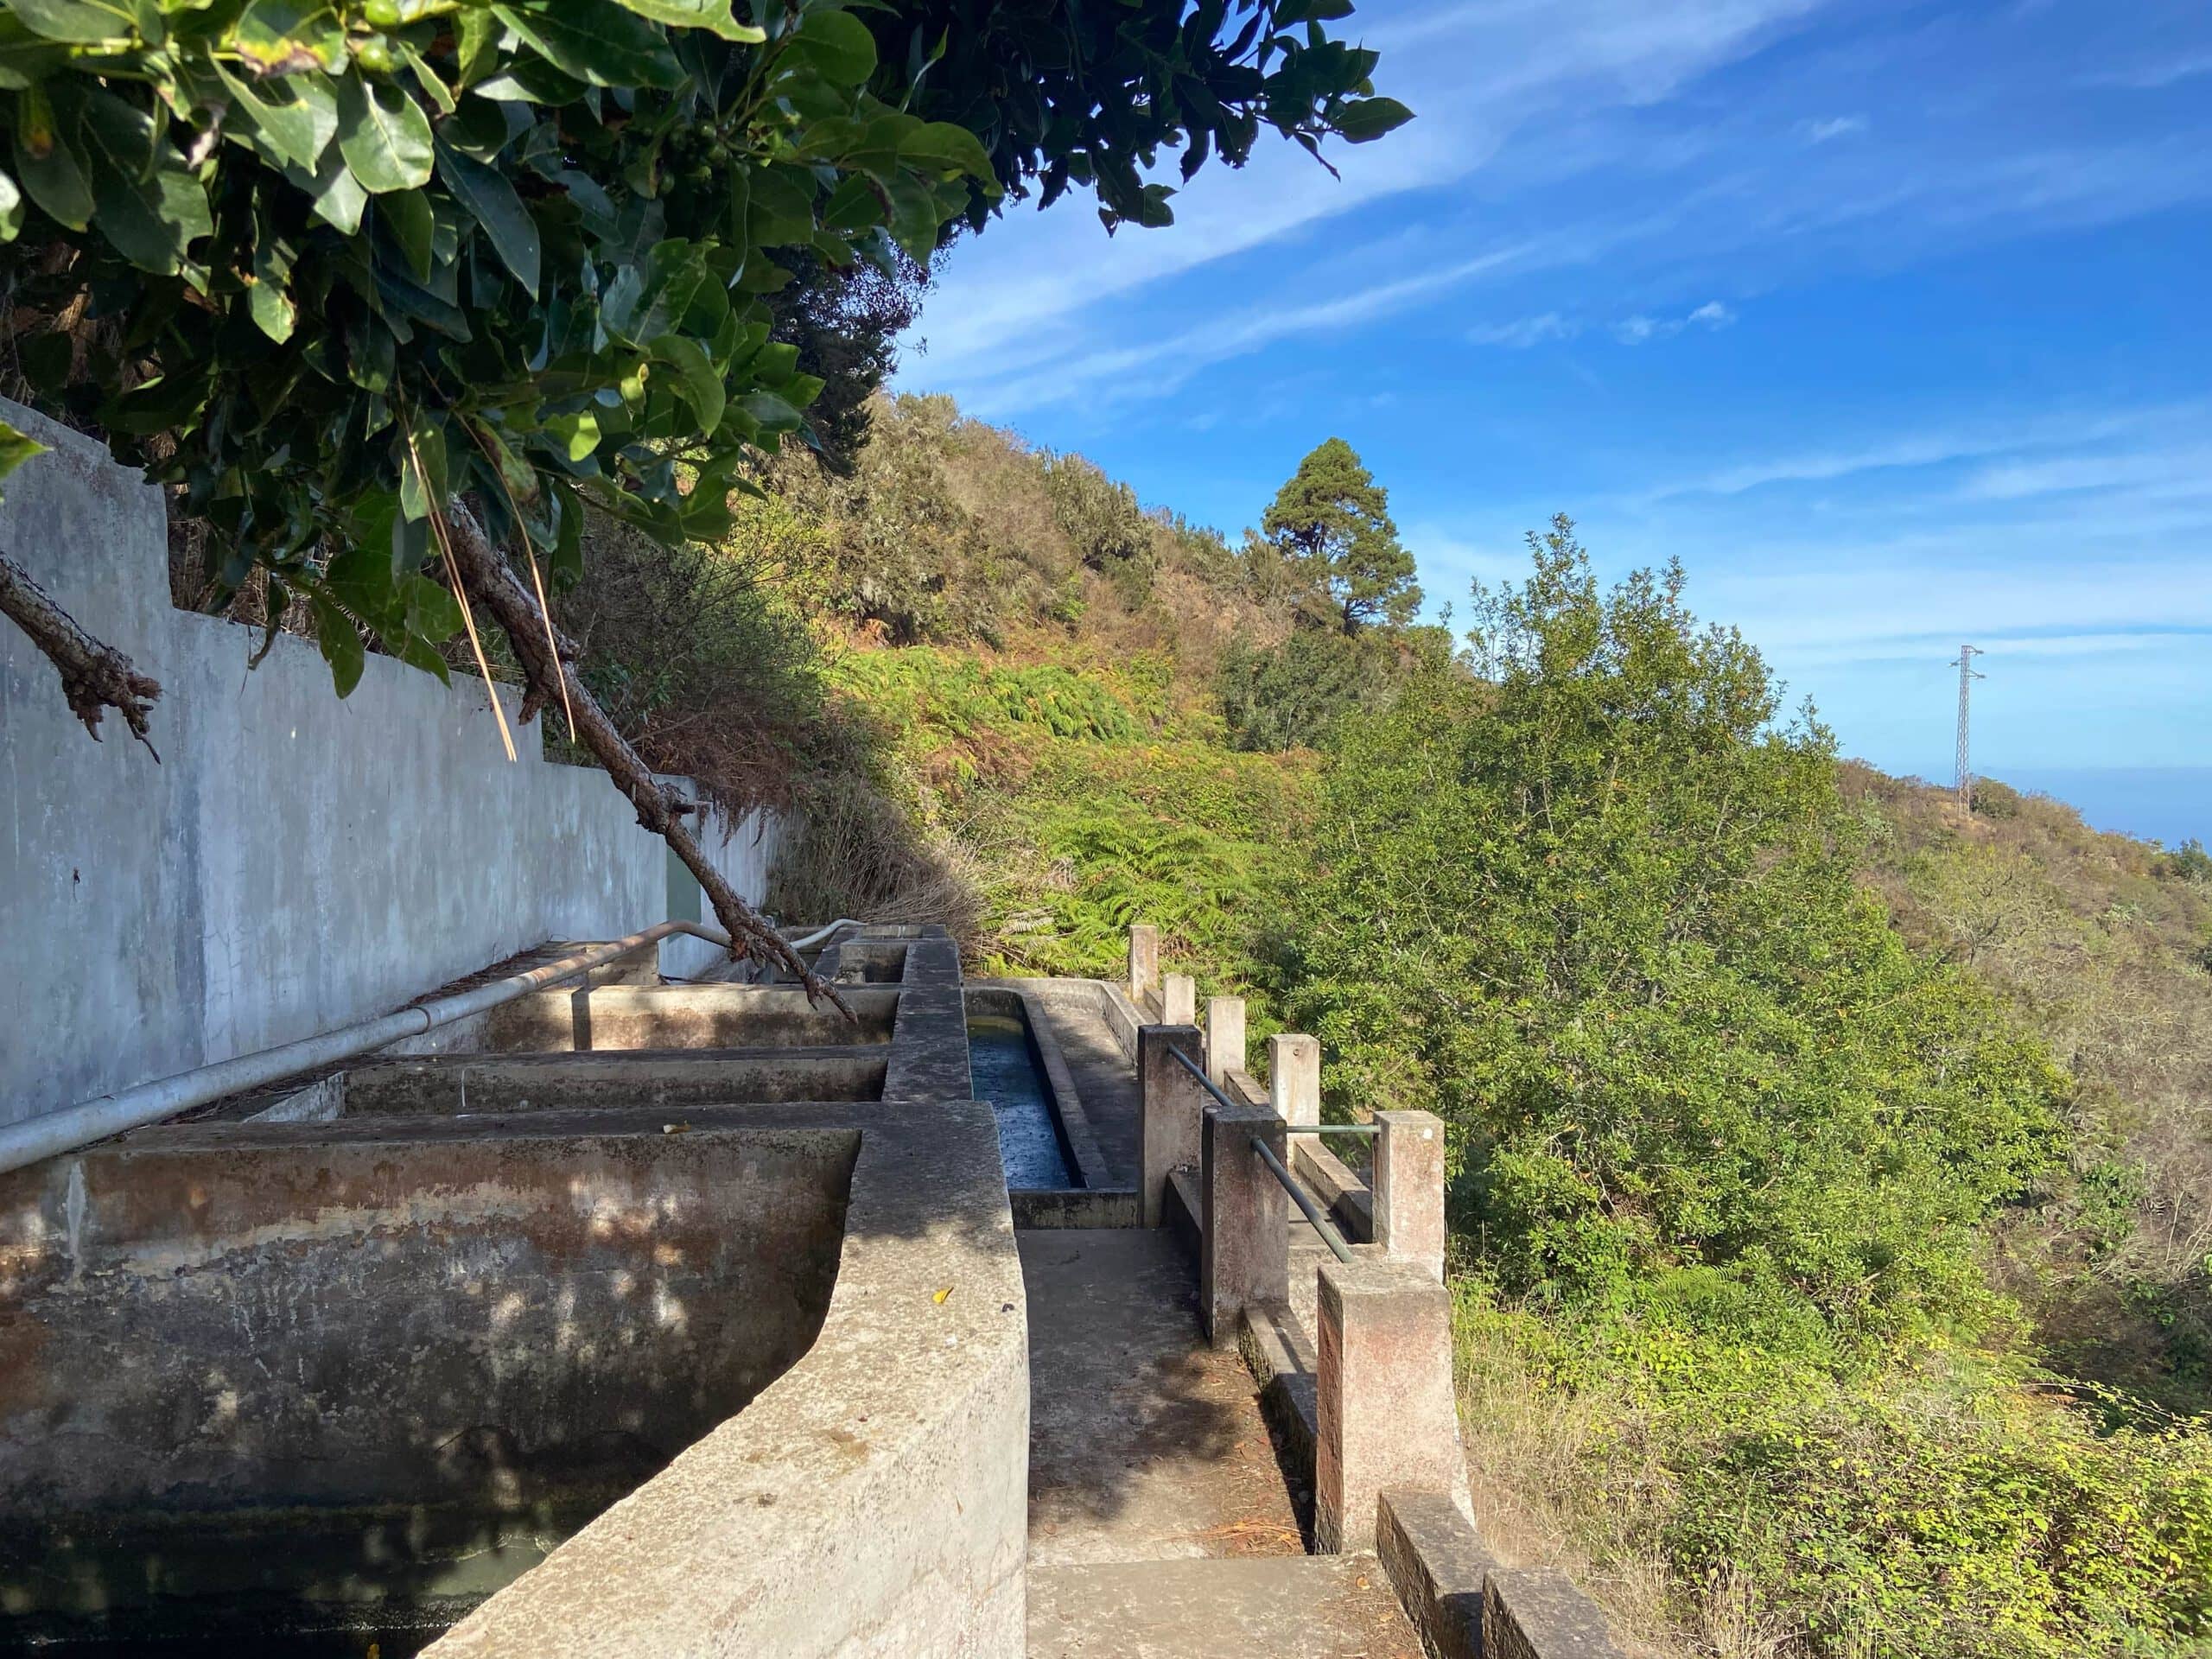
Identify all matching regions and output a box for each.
[0,0,1402,692]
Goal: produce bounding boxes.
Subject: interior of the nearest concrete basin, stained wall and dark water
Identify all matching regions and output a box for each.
[0,1113,861,1659]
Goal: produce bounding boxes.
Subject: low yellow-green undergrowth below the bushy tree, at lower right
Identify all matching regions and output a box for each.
[1458,1281,2212,1659]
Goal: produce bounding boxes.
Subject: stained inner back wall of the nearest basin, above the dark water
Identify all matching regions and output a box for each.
[0,1113,861,1524]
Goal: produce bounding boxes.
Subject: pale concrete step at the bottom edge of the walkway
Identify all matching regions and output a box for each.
[1028,1555,1422,1659]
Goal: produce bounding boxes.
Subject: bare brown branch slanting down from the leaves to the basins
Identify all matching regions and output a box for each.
[447,502,852,1018]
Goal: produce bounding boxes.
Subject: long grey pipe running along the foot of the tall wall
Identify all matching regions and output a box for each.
[0,923,730,1173]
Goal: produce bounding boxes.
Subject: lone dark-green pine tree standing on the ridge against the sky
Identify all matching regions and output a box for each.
[1261,438,1421,632]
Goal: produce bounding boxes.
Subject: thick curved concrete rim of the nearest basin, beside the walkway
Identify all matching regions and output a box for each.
[429,1102,1028,1659]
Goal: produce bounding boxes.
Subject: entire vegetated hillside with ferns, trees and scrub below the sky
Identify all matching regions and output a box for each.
[564,398,2212,1659]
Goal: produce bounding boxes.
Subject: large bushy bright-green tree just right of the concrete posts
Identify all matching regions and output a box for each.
[1289,520,2063,1334]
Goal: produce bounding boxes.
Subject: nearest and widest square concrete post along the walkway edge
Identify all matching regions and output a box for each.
[1314,1256,1469,1555]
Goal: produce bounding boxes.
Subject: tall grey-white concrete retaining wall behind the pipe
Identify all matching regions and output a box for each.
[0,403,777,1123]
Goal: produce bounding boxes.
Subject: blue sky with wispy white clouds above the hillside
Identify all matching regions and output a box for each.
[900,0,2212,838]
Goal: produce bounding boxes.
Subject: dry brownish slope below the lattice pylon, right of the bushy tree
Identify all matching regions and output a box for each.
[1845,767,2212,1411]
